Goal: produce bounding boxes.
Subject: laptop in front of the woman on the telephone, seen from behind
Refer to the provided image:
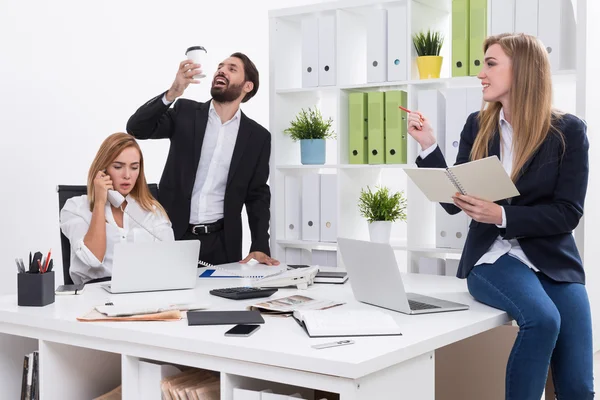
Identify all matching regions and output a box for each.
[102,240,200,293]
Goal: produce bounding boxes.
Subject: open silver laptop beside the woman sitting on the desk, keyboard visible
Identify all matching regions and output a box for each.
[338,238,469,314]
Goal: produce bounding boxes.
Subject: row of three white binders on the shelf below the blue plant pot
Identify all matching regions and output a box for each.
[284,173,337,242]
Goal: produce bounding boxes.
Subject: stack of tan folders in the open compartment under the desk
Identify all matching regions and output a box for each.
[160,368,221,400]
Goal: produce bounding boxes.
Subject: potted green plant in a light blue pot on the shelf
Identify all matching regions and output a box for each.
[284,107,335,165]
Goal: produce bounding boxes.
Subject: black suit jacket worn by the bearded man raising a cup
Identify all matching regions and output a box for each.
[127,93,271,262]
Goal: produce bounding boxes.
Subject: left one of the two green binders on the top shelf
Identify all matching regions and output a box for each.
[452,0,472,76]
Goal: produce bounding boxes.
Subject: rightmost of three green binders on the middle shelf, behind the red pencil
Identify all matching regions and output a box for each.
[385,90,408,164]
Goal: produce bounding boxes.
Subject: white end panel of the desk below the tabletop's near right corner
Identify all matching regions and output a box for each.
[340,352,435,400]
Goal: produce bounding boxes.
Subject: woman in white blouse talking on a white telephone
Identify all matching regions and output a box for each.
[60,133,174,284]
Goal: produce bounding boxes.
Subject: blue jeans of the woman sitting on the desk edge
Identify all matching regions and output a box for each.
[467,254,594,400]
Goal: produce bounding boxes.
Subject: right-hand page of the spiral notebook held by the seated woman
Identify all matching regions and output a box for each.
[449,156,519,201]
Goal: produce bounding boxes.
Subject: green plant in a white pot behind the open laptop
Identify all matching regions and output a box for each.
[358,186,406,243]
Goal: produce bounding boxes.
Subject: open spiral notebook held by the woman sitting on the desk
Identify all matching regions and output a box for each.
[404,156,519,203]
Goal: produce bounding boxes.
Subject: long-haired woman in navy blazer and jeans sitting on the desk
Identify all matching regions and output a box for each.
[408,34,594,400]
